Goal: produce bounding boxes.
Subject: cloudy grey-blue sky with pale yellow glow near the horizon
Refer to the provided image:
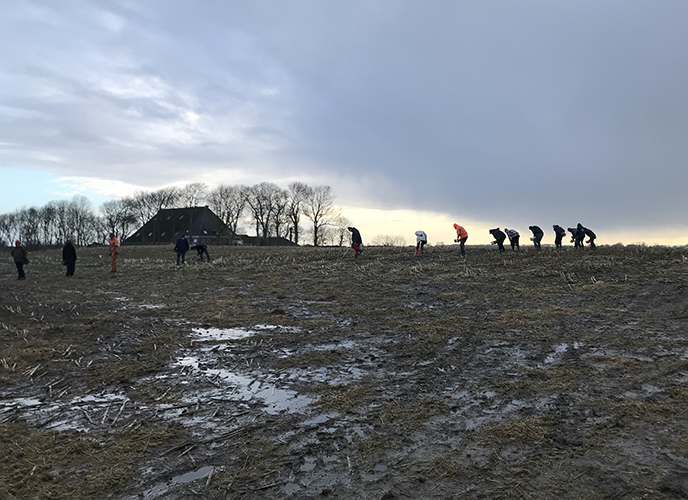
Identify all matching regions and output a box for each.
[0,0,688,244]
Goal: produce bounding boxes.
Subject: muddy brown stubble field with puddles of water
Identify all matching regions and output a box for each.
[0,247,688,500]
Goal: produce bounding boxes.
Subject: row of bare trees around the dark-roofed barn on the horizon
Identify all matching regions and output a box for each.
[0,182,350,246]
